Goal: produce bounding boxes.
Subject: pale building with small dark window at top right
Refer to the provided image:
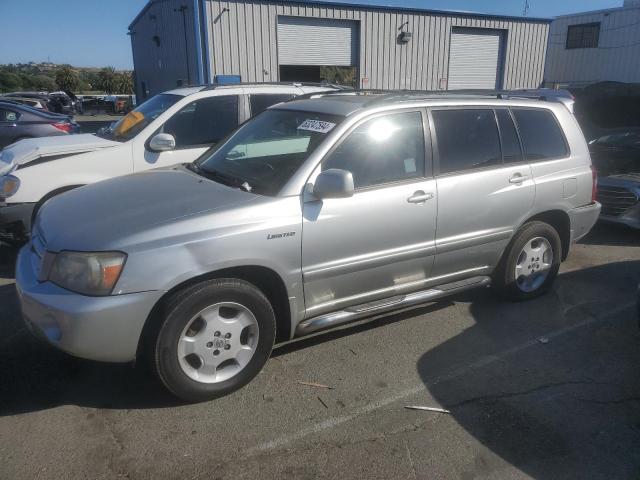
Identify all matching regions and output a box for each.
[545,0,640,86]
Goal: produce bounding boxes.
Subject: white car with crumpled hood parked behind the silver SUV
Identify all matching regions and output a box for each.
[0,84,340,241]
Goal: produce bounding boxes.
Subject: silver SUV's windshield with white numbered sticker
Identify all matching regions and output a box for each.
[195,110,343,195]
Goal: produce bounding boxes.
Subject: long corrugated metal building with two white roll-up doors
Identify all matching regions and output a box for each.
[129,0,550,98]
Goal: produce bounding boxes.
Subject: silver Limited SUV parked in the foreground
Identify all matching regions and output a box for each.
[16,93,600,401]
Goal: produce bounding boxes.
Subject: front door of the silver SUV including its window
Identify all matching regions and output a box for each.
[302,110,437,317]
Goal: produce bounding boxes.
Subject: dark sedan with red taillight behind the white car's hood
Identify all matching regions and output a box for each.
[0,101,80,148]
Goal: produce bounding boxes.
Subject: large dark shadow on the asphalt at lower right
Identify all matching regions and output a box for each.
[416,261,640,478]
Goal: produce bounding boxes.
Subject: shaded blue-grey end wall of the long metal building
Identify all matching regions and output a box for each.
[131,0,198,98]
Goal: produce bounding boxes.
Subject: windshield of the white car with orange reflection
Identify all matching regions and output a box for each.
[96,93,184,142]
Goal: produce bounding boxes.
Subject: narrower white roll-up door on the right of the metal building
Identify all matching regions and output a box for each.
[448,28,502,90]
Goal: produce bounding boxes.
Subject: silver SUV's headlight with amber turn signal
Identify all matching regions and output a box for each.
[49,252,127,296]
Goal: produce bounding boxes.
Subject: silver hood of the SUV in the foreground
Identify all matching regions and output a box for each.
[36,167,258,251]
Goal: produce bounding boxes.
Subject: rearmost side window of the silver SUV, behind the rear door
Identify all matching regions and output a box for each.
[512,108,569,161]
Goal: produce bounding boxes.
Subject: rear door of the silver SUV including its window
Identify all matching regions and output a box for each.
[430,107,535,276]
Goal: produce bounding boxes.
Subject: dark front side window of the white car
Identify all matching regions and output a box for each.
[162,95,238,148]
